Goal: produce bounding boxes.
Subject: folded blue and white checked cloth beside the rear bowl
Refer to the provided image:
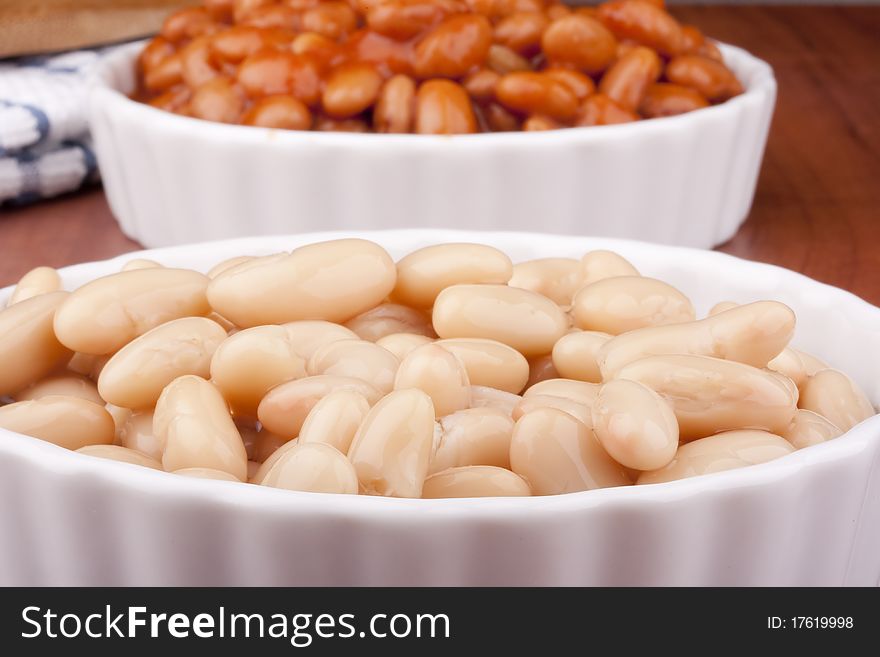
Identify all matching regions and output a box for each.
[0,47,129,205]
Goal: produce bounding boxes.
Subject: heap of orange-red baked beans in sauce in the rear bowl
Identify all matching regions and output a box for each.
[135,0,744,134]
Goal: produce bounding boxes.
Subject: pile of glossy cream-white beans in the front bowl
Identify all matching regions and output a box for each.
[0,239,874,498]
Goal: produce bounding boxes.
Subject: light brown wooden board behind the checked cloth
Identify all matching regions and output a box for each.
[0,0,199,57]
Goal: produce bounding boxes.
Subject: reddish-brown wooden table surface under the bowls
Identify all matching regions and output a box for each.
[0,6,880,305]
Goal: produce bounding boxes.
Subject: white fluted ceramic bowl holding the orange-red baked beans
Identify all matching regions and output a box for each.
[90,39,776,247]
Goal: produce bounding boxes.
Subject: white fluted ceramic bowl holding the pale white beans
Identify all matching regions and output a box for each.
[0,231,880,585]
